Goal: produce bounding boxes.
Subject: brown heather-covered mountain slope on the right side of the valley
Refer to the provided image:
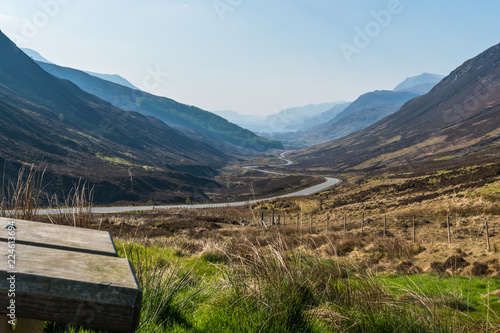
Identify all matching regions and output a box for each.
[292,44,500,172]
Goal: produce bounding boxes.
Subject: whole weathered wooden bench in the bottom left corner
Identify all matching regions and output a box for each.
[0,218,142,333]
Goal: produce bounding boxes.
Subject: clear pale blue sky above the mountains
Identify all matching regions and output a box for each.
[0,0,500,115]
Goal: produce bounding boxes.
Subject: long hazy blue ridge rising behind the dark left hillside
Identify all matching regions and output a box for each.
[38,62,283,151]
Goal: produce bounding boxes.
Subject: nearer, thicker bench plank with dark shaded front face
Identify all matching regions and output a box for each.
[0,242,142,332]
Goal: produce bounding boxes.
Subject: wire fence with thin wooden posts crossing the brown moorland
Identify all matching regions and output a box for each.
[247,212,500,251]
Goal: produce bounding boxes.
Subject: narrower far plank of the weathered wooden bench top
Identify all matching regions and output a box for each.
[0,218,117,256]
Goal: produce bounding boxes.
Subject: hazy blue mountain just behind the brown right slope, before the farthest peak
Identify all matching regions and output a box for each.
[305,90,418,144]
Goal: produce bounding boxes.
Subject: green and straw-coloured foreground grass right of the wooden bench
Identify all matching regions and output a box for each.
[46,233,500,333]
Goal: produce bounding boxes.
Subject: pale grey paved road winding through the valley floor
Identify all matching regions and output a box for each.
[34,151,340,215]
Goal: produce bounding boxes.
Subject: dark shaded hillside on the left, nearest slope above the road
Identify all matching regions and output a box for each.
[0,32,230,204]
